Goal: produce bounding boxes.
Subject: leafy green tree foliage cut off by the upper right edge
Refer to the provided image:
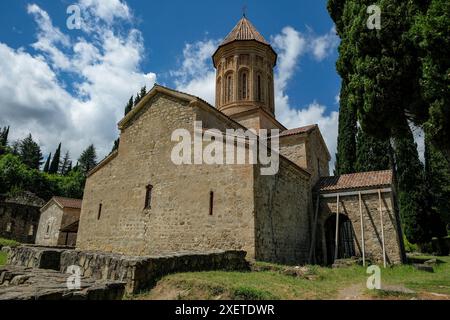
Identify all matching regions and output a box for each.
[410,0,450,163]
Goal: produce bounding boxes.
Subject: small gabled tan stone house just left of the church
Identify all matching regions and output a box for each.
[36,197,81,247]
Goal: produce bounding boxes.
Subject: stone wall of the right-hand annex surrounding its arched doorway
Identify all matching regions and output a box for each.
[317,190,402,264]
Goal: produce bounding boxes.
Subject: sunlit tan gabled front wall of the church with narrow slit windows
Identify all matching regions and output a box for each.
[77,94,254,257]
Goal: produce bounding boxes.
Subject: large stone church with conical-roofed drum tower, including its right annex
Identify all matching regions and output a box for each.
[77,17,403,264]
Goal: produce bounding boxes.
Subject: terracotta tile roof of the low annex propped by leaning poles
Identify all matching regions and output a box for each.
[318,170,392,192]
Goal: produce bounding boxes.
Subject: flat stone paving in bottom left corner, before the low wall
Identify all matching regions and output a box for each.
[0,266,125,300]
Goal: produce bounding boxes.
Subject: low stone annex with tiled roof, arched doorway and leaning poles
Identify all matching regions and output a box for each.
[315,170,405,265]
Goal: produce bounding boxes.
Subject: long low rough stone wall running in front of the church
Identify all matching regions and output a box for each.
[7,246,249,293]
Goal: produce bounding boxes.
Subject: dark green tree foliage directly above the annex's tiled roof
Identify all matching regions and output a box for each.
[355,128,391,172]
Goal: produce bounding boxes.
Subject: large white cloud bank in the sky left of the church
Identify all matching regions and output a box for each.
[0,0,156,159]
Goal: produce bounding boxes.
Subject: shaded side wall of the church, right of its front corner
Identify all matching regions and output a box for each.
[255,158,311,265]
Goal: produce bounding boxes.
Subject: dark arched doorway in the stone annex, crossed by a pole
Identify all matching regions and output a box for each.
[325,214,356,265]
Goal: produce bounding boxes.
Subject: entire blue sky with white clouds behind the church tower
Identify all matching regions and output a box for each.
[0,0,340,162]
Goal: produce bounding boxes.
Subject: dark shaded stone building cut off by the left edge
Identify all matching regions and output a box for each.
[0,191,45,243]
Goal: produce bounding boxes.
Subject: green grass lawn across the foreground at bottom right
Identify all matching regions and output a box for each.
[128,257,450,300]
